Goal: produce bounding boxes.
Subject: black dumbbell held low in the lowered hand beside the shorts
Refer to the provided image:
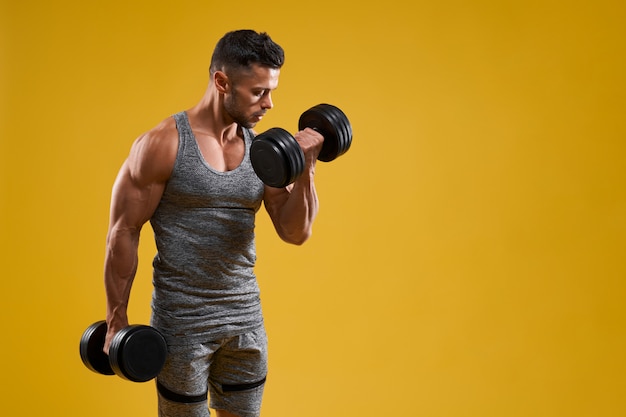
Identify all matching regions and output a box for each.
[80,320,167,382]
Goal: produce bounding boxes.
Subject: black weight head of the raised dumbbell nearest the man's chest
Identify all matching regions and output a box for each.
[250,127,304,188]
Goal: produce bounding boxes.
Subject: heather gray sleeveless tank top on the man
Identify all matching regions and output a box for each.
[150,112,264,344]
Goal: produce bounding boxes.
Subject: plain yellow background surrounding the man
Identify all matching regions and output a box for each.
[0,0,626,417]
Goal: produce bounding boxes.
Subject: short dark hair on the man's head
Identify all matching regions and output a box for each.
[210,29,285,75]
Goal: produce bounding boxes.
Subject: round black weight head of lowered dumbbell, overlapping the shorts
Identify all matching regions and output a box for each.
[109,325,167,382]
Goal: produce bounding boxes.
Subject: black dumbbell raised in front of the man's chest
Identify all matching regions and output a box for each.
[250,104,352,188]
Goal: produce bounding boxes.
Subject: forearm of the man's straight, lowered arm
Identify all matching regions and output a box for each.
[104,228,139,330]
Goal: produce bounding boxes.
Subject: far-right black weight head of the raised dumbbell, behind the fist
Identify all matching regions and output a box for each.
[298,103,352,162]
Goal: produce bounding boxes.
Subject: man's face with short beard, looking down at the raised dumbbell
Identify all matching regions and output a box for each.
[224,65,280,129]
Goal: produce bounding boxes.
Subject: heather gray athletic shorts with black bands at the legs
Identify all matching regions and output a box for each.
[157,327,267,417]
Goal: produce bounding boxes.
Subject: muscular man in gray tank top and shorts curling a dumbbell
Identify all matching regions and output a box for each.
[104,30,323,417]
